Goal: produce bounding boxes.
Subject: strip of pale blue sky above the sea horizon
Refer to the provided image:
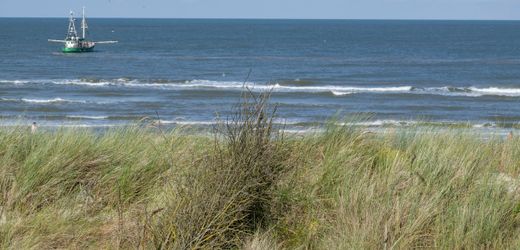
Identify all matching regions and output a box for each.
[0,0,520,20]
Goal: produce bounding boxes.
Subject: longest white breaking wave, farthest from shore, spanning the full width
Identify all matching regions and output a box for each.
[0,78,520,97]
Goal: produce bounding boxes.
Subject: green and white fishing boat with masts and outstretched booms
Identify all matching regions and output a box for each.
[48,7,117,53]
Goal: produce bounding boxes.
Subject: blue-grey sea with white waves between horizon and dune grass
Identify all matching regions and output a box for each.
[0,18,520,129]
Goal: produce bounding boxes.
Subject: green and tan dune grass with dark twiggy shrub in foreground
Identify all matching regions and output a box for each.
[0,93,520,249]
